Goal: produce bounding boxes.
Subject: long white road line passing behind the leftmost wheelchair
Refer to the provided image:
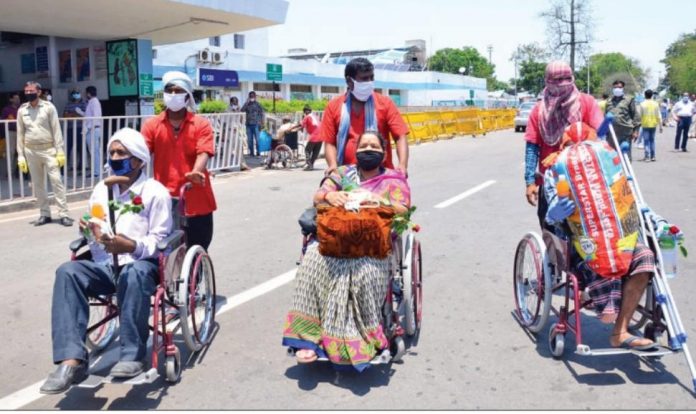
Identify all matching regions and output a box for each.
[0,269,297,410]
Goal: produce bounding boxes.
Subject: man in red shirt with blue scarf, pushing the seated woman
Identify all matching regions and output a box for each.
[319,58,408,174]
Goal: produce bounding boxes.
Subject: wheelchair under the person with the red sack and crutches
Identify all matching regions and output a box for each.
[513,230,678,359]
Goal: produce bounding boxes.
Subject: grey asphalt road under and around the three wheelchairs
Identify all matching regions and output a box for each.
[0,128,696,409]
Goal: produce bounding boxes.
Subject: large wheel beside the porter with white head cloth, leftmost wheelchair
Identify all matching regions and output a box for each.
[178,246,216,352]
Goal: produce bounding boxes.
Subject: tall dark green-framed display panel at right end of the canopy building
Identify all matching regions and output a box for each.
[106,39,139,97]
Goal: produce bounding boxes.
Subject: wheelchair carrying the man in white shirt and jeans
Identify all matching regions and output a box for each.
[70,183,216,388]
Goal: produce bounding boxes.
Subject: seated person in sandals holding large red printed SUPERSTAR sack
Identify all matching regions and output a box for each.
[543,122,656,350]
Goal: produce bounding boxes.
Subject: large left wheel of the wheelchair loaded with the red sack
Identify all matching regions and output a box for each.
[513,232,553,333]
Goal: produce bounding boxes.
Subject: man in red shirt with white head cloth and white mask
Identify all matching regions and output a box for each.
[141,71,217,250]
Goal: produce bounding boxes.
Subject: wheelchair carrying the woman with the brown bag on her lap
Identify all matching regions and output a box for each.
[296,215,423,364]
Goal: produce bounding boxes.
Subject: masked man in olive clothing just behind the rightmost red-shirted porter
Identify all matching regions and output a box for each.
[604,79,641,161]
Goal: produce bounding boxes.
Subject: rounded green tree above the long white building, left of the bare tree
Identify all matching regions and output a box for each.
[428,46,499,91]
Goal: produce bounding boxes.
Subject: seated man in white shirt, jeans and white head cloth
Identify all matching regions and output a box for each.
[41,128,172,394]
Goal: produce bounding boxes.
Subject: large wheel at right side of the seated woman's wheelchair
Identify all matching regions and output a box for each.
[403,235,423,336]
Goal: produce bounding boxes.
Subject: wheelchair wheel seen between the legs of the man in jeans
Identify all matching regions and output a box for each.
[85,296,118,353]
